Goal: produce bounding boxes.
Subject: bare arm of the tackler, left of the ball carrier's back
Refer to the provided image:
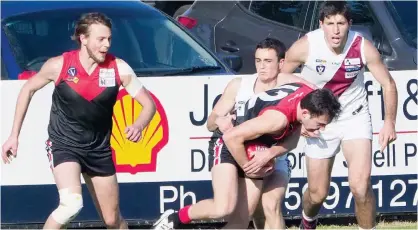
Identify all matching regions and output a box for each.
[206,78,241,132]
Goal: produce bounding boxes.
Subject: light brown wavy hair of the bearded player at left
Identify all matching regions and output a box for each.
[71,12,112,45]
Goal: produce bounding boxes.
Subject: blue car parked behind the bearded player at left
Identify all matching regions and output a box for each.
[1,1,240,79]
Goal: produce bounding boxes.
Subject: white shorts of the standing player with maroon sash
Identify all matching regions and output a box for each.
[304,107,373,159]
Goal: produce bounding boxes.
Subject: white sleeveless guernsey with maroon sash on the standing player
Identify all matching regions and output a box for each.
[301,29,368,119]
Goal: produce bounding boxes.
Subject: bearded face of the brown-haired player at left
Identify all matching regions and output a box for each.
[81,24,112,63]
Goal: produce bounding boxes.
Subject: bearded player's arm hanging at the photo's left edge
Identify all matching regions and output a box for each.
[2,56,63,163]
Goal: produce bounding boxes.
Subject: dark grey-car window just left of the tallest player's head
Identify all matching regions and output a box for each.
[249,1,309,29]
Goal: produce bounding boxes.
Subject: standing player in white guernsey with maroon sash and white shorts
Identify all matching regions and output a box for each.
[282,1,397,229]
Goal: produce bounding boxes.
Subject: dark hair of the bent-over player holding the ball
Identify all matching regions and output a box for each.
[300,88,341,120]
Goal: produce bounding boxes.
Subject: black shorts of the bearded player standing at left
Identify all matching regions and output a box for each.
[45,140,116,176]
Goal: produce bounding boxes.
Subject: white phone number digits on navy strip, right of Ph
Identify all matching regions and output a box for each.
[283,174,418,215]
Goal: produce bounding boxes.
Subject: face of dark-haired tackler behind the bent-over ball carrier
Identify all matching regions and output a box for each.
[255,49,284,80]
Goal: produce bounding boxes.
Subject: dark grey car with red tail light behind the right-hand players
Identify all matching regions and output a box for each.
[178,1,417,74]
